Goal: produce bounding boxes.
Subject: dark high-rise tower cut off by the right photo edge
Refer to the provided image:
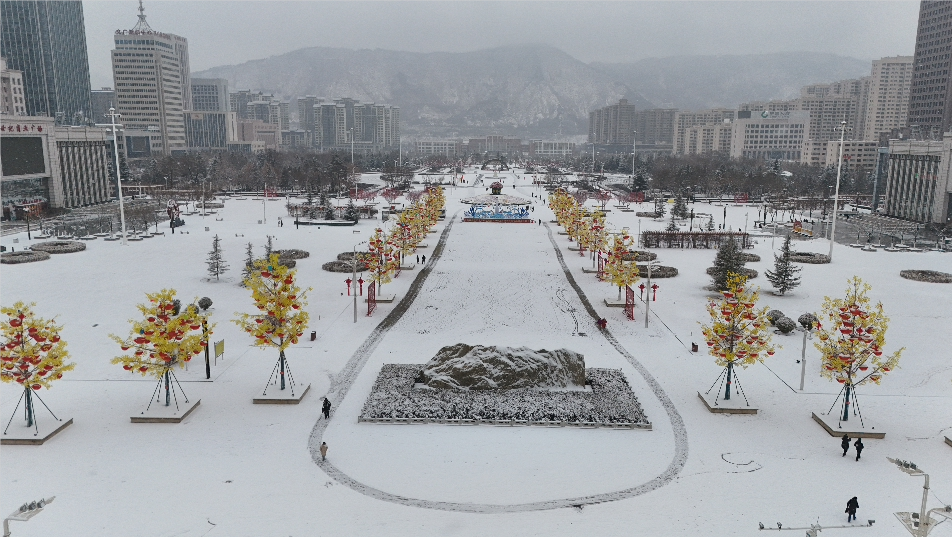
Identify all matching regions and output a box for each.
[908,0,952,140]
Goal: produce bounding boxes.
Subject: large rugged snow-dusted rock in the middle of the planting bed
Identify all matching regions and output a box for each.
[417,343,585,390]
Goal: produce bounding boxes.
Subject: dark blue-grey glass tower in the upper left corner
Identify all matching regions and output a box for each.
[0,0,89,125]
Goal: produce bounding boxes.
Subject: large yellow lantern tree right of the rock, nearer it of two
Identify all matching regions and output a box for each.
[701,272,775,405]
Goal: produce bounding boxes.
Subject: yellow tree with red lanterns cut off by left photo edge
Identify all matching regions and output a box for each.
[0,302,76,434]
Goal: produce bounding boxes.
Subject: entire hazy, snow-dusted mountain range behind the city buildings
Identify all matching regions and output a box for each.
[192,44,870,138]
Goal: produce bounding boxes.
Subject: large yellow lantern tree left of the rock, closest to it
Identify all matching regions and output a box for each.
[233,254,311,397]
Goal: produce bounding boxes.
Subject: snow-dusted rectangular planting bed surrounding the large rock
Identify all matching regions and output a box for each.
[359,364,650,428]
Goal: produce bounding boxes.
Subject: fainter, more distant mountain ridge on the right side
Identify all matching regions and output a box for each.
[592,52,872,110]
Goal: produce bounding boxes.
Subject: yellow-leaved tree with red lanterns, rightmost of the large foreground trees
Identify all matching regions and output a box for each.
[814,276,905,422]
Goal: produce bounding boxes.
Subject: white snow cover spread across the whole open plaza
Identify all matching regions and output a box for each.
[0,170,952,537]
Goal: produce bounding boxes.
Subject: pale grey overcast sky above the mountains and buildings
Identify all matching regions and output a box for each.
[83,0,919,88]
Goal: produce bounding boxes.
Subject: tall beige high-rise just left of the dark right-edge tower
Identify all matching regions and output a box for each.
[856,56,913,140]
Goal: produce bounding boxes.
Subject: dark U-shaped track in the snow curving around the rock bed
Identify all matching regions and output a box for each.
[308,217,688,513]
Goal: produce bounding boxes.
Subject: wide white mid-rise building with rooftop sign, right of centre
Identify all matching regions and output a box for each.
[730,111,810,161]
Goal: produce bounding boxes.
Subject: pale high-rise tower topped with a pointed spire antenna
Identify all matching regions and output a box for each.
[112,0,192,155]
